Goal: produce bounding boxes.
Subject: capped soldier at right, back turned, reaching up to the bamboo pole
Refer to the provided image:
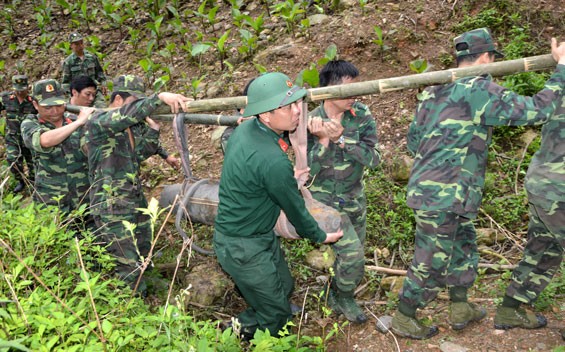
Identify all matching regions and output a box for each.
[392,28,565,339]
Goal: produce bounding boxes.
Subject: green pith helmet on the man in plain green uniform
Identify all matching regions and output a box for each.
[243,72,306,117]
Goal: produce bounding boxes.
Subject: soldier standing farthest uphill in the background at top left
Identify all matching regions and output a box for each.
[61,33,106,108]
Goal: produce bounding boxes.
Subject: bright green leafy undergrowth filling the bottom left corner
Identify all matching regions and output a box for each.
[0,195,241,351]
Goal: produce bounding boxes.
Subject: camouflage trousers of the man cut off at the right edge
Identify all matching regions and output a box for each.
[506,199,565,304]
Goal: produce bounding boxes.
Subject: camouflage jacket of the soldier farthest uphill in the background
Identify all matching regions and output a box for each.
[61,50,106,93]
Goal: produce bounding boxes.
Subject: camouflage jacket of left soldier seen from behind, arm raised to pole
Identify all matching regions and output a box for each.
[83,95,161,215]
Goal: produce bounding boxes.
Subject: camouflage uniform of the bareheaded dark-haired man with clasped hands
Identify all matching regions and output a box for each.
[308,102,380,302]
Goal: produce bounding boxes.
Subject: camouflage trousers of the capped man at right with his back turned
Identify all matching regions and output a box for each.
[400,210,479,308]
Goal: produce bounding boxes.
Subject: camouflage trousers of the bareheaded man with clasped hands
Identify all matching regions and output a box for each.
[331,215,365,293]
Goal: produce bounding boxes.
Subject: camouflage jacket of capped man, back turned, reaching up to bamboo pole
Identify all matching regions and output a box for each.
[407,65,565,218]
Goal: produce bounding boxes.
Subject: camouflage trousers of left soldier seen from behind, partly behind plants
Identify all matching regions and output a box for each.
[93,212,152,287]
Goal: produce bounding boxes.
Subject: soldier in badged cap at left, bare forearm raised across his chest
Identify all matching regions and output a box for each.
[21,79,93,214]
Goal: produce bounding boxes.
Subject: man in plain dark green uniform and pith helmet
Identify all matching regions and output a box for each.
[214,72,342,338]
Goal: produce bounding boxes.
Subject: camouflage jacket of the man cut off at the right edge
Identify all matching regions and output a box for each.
[525,97,565,207]
